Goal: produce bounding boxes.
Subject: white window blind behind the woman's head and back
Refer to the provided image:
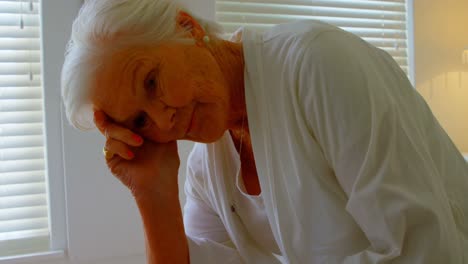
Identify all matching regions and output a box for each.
[216,0,409,74]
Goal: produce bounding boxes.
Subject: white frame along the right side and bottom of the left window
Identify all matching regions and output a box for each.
[0,0,82,264]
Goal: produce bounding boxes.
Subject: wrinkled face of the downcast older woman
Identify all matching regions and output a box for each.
[91,43,229,142]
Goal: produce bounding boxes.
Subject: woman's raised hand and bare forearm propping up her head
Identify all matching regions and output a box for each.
[94,111,189,263]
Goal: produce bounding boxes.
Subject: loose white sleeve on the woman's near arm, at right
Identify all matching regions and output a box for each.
[297,29,461,264]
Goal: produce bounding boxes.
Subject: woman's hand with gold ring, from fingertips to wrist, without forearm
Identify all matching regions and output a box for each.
[94,111,180,198]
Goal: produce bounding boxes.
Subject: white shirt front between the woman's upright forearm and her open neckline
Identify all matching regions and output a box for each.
[184,132,279,264]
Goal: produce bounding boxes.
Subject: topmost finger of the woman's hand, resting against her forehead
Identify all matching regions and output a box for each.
[94,110,143,147]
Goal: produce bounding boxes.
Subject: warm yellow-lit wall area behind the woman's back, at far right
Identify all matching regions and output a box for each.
[414,0,468,153]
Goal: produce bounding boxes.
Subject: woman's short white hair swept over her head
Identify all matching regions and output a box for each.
[61,0,222,130]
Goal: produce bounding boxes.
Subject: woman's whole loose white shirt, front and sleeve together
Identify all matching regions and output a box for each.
[184,21,468,264]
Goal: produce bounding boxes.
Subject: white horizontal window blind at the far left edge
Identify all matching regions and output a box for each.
[0,0,49,257]
